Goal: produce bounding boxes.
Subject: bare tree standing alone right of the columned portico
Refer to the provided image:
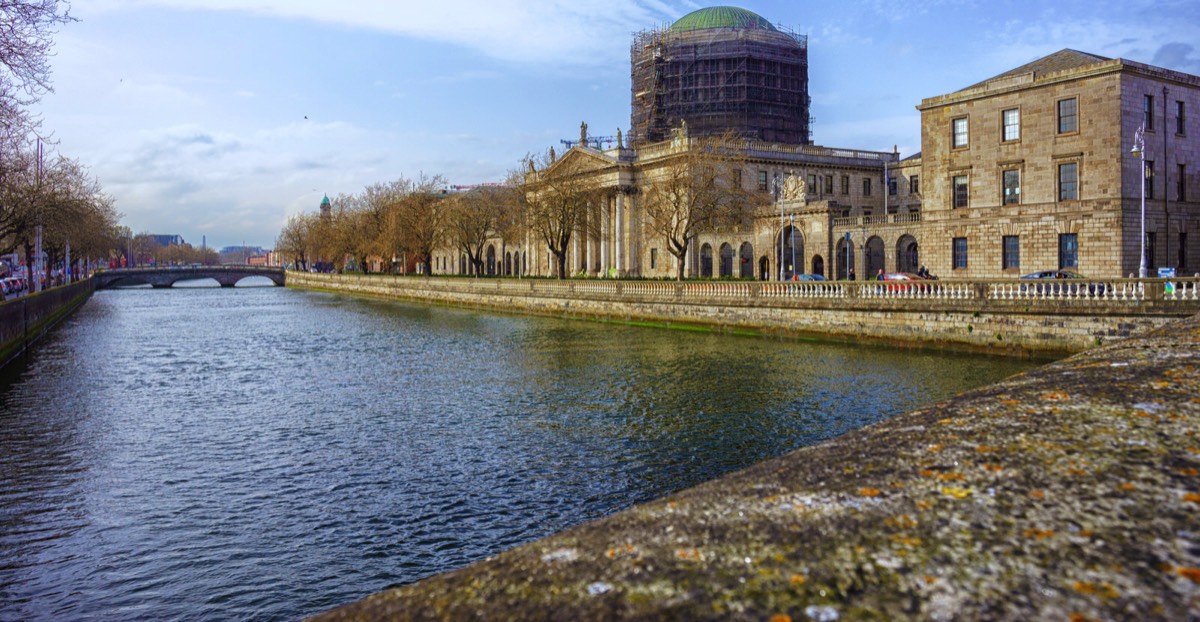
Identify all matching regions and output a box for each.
[642,132,754,281]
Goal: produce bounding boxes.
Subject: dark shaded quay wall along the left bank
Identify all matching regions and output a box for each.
[0,279,95,367]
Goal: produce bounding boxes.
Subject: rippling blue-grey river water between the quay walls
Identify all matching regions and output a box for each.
[0,287,1031,621]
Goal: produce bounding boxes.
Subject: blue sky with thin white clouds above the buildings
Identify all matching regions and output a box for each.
[35,0,1200,249]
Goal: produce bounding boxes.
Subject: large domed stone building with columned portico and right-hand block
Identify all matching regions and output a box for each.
[434,7,1200,280]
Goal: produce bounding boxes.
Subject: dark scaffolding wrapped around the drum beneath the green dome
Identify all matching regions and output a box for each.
[630,25,811,145]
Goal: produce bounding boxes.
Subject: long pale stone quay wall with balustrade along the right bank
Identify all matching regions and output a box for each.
[287,271,1200,355]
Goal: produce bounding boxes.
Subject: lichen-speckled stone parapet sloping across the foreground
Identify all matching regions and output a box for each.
[312,309,1200,622]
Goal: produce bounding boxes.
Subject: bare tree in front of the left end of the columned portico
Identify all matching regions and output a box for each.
[520,152,602,279]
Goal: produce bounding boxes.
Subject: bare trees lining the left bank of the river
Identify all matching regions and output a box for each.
[0,0,121,276]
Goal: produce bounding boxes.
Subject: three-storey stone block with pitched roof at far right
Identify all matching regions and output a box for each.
[918,50,1200,277]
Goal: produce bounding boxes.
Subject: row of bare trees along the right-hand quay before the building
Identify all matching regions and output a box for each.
[276,133,761,280]
